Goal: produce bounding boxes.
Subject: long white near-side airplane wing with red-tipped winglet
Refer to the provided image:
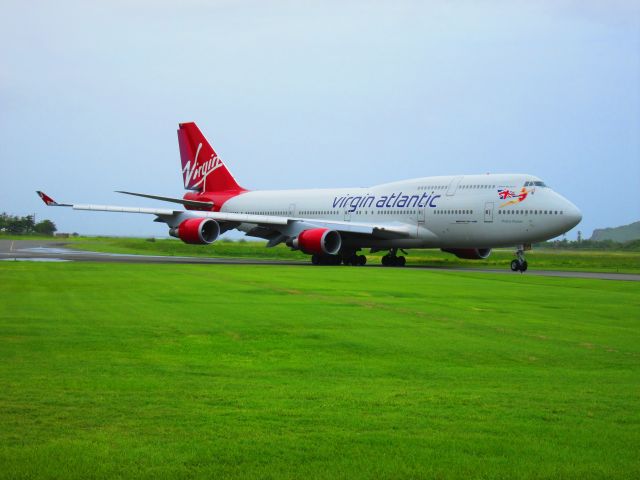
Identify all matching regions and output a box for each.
[37,191,410,242]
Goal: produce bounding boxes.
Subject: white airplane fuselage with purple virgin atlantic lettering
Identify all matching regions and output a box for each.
[221,174,582,248]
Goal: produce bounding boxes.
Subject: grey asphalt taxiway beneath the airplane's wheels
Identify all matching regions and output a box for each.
[0,240,640,282]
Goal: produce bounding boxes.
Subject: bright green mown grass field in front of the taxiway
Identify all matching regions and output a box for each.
[0,262,640,479]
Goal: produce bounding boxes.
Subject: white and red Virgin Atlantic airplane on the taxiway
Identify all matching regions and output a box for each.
[37,122,582,272]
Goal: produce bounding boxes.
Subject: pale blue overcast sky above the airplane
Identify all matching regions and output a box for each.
[0,0,640,238]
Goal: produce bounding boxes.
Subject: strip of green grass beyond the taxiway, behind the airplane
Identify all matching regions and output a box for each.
[69,237,640,273]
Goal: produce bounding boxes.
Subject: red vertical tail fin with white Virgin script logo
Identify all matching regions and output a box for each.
[178,122,245,192]
